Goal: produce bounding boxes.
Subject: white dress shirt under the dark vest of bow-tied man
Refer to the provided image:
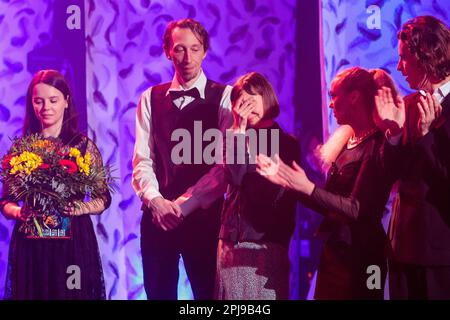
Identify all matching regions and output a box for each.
[132,70,233,216]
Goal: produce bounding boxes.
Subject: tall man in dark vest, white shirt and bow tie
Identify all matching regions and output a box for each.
[133,19,232,299]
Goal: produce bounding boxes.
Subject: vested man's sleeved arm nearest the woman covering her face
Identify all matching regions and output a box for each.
[175,86,233,216]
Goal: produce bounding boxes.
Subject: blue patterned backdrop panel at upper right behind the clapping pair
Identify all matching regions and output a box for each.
[322,0,450,133]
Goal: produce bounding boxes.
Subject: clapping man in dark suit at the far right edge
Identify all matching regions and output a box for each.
[376,16,450,299]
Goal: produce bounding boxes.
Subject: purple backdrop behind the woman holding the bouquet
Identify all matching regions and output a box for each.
[0,0,87,297]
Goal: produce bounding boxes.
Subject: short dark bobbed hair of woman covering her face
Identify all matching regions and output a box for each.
[231,72,280,119]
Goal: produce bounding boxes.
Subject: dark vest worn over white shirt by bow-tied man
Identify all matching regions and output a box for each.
[151,80,225,200]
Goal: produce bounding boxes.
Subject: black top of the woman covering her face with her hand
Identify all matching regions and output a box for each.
[219,123,300,247]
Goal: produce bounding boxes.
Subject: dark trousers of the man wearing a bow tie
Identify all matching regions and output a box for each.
[141,209,219,300]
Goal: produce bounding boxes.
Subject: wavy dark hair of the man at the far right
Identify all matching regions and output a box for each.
[397,16,450,81]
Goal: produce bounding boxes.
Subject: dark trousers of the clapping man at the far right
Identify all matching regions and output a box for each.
[389,260,450,300]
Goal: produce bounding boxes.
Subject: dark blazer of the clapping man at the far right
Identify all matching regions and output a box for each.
[383,90,450,266]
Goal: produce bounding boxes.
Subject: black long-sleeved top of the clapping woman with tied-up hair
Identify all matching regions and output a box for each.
[303,131,392,255]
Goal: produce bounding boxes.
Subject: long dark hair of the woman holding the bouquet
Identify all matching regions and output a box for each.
[23,70,79,143]
